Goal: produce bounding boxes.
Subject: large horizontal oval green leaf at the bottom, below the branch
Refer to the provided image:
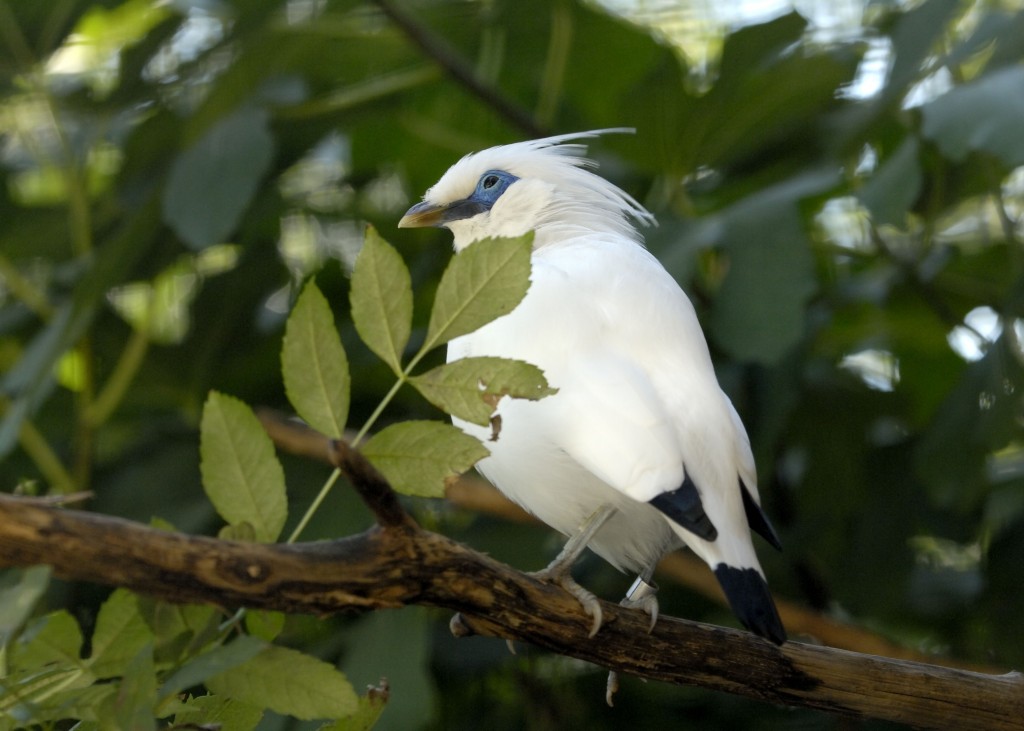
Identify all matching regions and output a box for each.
[206,646,358,721]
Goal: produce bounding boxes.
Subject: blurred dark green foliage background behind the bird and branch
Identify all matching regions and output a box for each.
[0,0,1024,729]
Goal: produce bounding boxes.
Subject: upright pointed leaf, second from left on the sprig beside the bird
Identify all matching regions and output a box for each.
[281,281,351,439]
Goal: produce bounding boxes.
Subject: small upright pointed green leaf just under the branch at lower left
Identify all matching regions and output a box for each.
[89,589,154,678]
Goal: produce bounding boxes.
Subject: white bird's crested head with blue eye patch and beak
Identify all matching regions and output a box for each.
[398,130,653,251]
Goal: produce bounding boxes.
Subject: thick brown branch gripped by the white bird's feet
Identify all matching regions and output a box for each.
[0,487,1024,731]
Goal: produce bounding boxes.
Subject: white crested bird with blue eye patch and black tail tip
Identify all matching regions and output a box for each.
[398,130,786,644]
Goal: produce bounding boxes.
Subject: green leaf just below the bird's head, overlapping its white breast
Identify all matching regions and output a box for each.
[423,232,534,351]
